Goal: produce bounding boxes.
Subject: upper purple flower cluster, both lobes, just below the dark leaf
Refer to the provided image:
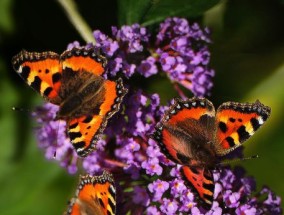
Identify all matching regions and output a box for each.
[68,18,214,96]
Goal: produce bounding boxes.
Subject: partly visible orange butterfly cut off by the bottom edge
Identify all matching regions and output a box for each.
[64,171,116,215]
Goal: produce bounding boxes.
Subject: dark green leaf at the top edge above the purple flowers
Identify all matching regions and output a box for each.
[118,0,220,26]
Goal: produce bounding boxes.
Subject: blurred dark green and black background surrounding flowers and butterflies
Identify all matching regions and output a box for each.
[0,0,284,215]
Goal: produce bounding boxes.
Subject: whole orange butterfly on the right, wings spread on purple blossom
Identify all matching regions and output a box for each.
[153,98,271,207]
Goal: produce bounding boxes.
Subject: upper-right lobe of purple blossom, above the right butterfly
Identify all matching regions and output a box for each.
[156,18,214,96]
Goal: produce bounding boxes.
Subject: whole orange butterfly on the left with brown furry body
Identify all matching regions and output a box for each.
[12,48,127,157]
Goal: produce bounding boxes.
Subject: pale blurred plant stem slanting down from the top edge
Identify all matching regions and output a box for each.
[57,0,96,44]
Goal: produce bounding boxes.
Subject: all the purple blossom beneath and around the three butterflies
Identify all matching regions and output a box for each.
[31,18,281,215]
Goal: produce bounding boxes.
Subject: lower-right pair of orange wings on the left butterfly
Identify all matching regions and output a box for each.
[67,79,127,157]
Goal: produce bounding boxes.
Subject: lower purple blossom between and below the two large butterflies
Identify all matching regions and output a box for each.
[35,91,282,215]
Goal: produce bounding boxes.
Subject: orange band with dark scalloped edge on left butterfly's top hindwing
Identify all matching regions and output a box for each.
[60,48,106,76]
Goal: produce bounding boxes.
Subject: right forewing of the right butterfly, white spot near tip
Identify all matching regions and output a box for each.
[215,100,271,155]
